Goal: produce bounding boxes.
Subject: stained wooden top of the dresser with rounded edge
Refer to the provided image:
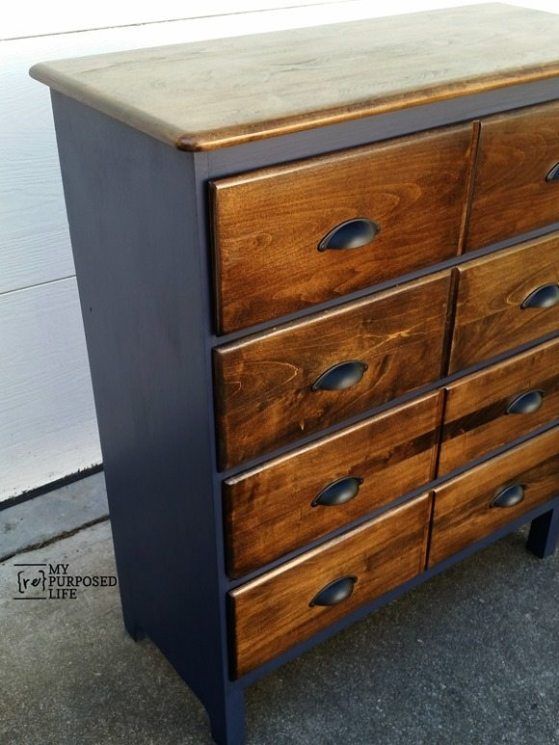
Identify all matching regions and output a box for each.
[30,4,559,150]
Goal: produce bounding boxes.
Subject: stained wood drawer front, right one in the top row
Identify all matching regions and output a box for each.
[467,103,559,249]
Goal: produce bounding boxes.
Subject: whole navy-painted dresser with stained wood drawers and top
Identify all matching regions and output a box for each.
[31,5,559,745]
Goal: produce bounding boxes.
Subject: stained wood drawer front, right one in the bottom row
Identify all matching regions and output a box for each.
[429,427,559,565]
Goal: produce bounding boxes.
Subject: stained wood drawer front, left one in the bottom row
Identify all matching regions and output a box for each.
[231,495,431,677]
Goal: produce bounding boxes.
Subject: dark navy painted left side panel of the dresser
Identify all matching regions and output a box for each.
[48,93,243,745]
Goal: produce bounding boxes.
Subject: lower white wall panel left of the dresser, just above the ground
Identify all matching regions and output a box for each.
[0,278,101,499]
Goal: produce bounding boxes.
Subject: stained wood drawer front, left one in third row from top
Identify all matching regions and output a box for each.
[223,392,442,577]
